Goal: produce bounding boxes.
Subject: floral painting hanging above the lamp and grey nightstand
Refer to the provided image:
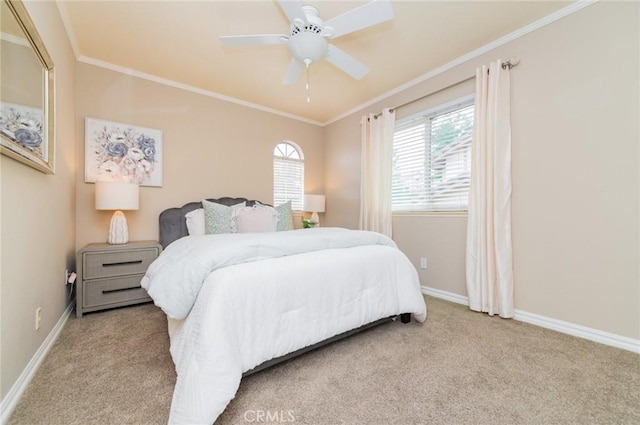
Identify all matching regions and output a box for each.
[85,117,162,186]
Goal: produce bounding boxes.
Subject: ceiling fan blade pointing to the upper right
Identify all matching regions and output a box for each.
[324,0,393,38]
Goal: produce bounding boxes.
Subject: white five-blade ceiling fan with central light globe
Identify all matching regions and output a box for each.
[220,0,393,88]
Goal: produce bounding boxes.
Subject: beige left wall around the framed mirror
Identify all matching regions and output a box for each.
[0,2,76,398]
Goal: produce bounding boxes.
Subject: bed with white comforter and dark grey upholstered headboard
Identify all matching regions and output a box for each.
[142,198,426,424]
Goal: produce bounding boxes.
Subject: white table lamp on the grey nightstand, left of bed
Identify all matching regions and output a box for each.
[96,181,139,245]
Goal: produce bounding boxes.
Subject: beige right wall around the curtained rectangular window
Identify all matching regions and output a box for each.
[325,2,640,339]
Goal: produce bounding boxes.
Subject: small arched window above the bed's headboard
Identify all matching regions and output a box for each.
[273,142,304,211]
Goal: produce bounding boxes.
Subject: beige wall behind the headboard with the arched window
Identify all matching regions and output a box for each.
[76,63,324,248]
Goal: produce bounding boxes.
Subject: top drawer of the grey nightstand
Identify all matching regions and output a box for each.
[83,249,158,279]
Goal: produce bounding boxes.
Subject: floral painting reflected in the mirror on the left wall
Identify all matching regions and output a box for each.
[0,103,48,160]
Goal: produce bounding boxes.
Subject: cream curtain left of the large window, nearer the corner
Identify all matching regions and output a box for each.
[360,109,396,237]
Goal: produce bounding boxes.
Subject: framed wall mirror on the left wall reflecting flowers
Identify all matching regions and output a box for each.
[0,0,55,174]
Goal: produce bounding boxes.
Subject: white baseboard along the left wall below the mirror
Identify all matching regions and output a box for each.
[0,303,75,424]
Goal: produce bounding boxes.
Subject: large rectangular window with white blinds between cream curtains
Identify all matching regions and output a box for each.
[391,97,474,212]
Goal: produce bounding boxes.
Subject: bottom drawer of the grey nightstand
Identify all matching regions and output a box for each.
[83,275,151,308]
